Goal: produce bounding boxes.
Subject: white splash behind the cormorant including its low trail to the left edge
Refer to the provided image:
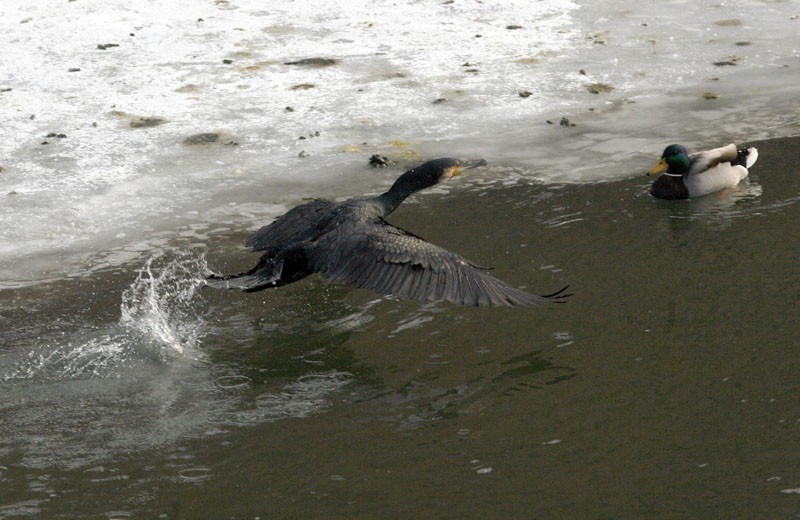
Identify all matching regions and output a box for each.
[0,253,207,384]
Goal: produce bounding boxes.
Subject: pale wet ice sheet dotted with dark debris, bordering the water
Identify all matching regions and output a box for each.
[0,0,800,286]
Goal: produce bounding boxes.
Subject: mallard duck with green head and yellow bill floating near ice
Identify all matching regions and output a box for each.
[648,143,758,200]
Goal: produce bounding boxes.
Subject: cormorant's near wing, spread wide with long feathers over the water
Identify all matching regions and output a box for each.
[307,221,547,306]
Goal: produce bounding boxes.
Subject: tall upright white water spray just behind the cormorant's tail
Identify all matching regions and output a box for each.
[119,252,208,354]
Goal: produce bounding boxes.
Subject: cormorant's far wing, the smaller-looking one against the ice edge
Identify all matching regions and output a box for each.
[245,199,335,256]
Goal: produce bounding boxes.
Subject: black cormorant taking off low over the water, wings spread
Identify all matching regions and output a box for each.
[207,159,566,305]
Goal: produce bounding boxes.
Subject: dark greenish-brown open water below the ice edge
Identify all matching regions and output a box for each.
[0,139,800,518]
